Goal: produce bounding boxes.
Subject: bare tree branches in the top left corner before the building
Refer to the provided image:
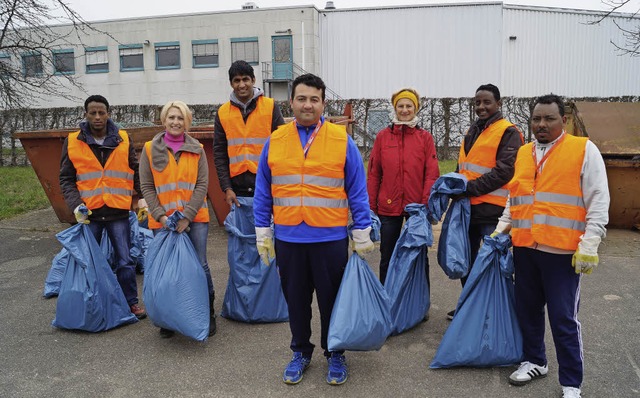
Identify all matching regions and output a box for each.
[0,0,104,109]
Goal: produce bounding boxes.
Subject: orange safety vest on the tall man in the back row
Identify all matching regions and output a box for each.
[218,96,274,177]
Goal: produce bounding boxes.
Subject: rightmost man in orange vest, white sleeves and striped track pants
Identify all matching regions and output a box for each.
[496,94,609,398]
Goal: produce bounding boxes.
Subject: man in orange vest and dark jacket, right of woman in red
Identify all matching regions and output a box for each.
[447,84,524,320]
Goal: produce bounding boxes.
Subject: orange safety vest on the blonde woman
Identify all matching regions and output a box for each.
[144,141,209,229]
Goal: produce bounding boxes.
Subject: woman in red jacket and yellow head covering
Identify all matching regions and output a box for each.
[367,88,440,284]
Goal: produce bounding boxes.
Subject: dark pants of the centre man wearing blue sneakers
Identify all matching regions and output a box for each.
[275,238,349,356]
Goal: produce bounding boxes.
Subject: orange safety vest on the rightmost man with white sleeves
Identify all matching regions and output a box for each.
[507,135,587,250]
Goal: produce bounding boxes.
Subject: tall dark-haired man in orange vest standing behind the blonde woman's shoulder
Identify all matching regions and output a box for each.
[213,61,284,206]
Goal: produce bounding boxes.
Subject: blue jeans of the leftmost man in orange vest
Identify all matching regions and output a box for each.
[87,218,138,305]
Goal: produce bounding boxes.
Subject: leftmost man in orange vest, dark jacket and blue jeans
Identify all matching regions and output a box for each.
[60,95,147,319]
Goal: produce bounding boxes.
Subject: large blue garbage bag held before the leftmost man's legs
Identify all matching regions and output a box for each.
[52,224,138,332]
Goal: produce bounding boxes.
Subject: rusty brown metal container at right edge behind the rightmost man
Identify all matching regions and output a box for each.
[567,102,640,229]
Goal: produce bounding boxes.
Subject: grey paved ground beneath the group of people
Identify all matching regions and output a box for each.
[0,209,640,398]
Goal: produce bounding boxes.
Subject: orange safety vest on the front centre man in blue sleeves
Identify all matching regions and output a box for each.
[267,122,349,227]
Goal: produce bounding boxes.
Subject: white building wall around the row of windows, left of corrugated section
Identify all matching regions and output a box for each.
[40,6,319,107]
